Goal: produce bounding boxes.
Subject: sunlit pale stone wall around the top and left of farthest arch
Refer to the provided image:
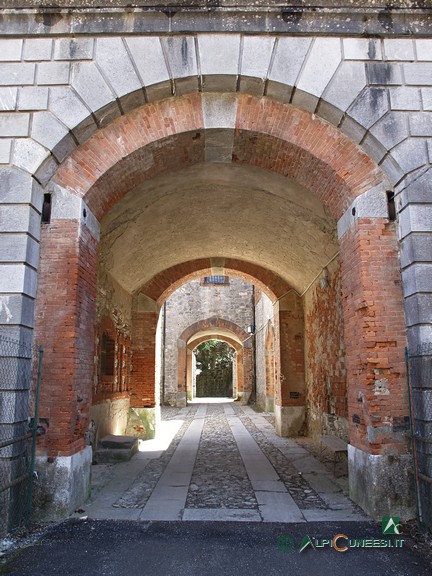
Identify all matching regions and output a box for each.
[165,278,253,403]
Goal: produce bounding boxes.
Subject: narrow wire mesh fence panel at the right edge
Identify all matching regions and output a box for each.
[406,342,432,530]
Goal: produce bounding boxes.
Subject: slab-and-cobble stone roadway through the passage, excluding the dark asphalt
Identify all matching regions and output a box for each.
[77,402,368,522]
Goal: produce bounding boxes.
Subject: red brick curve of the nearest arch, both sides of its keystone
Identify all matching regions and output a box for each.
[54,94,384,220]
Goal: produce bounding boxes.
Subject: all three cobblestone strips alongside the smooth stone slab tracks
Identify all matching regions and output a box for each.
[108,403,352,510]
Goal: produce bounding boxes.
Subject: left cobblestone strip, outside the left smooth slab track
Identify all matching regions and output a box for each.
[113,406,198,508]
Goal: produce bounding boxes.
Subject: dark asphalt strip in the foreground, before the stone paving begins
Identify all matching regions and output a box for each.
[0,519,432,576]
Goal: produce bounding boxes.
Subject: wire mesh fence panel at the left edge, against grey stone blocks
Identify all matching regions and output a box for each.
[0,335,45,537]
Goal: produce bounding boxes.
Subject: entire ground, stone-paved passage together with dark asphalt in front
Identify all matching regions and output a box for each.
[0,403,432,576]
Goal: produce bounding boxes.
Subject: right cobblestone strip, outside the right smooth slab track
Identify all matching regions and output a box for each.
[233,404,328,510]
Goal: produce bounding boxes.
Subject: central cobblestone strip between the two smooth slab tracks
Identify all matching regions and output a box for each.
[186,405,258,509]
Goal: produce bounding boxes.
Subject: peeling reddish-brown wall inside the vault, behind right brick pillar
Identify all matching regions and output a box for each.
[304,259,348,440]
